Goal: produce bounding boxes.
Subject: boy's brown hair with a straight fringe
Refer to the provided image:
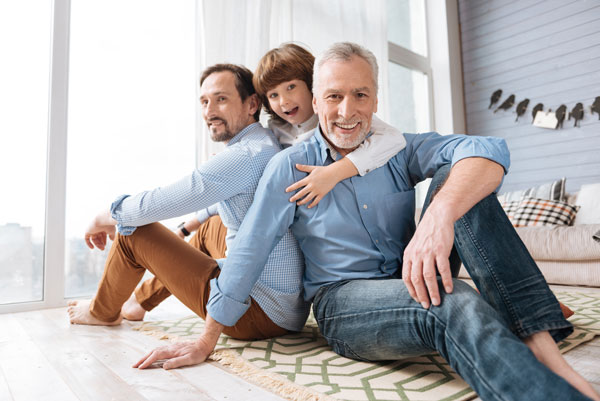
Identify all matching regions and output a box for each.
[252,43,315,121]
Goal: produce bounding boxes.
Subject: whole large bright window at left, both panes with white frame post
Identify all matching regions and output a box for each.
[0,0,198,313]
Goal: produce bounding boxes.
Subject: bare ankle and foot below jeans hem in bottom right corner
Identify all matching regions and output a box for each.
[523,331,600,401]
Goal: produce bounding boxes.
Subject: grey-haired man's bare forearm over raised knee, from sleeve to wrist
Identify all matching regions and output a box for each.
[427,157,504,222]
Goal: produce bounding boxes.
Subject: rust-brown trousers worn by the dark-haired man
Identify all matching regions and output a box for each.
[90,216,287,340]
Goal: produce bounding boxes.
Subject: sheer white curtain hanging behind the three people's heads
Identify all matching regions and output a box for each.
[196,0,388,162]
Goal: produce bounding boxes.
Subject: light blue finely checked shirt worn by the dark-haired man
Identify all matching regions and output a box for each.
[111,123,309,330]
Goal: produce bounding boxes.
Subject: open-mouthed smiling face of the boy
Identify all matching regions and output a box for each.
[266,79,314,124]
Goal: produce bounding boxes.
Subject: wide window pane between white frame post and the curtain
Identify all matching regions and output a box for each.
[64,0,198,297]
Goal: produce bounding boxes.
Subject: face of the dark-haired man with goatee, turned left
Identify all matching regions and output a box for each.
[200,71,258,142]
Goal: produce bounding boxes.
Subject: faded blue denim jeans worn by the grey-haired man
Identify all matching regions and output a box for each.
[313,167,588,400]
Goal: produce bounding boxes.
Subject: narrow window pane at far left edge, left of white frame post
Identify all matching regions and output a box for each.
[0,0,52,304]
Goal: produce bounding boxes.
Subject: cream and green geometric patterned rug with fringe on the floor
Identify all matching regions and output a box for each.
[134,291,600,401]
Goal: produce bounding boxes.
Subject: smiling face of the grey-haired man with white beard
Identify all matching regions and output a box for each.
[313,56,377,156]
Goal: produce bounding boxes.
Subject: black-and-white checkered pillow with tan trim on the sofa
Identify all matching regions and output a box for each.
[507,197,579,227]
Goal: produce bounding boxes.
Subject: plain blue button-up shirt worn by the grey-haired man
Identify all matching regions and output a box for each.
[208,128,510,323]
